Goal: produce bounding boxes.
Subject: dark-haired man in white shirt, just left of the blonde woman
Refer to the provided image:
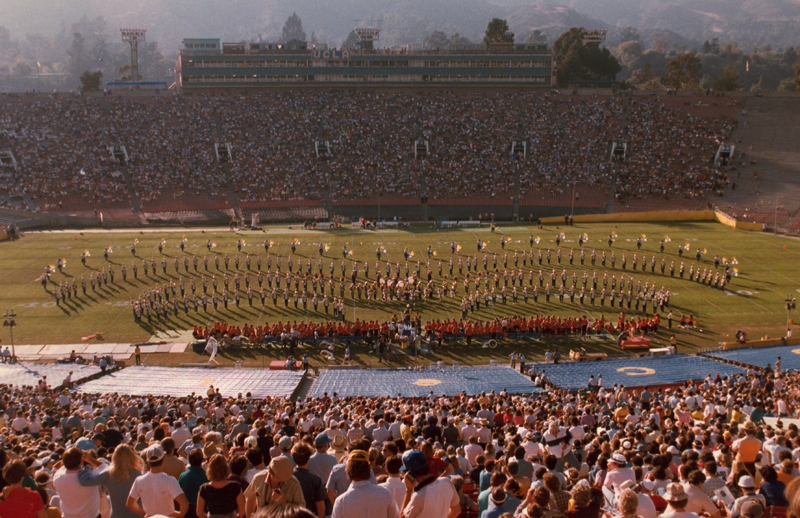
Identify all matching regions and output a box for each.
[53,448,100,518]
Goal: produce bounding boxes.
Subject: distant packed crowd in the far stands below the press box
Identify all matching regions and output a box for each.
[0,92,735,210]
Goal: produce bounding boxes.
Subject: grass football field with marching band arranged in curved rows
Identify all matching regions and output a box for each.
[0,222,800,370]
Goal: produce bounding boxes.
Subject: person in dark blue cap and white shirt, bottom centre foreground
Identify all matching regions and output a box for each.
[400,450,460,518]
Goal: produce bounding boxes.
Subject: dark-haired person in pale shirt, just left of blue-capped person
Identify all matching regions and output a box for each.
[331,450,400,518]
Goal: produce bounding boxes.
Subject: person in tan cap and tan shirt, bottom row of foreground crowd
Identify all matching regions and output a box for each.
[244,455,306,516]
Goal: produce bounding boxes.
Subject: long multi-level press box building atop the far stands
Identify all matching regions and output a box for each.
[175,39,553,90]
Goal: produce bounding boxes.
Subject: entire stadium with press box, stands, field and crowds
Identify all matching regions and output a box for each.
[0,29,800,518]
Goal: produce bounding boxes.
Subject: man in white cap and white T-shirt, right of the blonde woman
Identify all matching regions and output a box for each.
[126,443,189,518]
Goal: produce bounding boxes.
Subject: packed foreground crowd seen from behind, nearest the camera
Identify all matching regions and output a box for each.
[0,356,800,518]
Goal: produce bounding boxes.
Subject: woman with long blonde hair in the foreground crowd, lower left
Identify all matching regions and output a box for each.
[78,444,144,518]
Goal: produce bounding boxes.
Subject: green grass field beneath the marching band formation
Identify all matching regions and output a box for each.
[0,222,800,370]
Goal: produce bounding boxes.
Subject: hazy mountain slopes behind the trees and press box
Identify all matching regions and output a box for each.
[0,0,800,52]
